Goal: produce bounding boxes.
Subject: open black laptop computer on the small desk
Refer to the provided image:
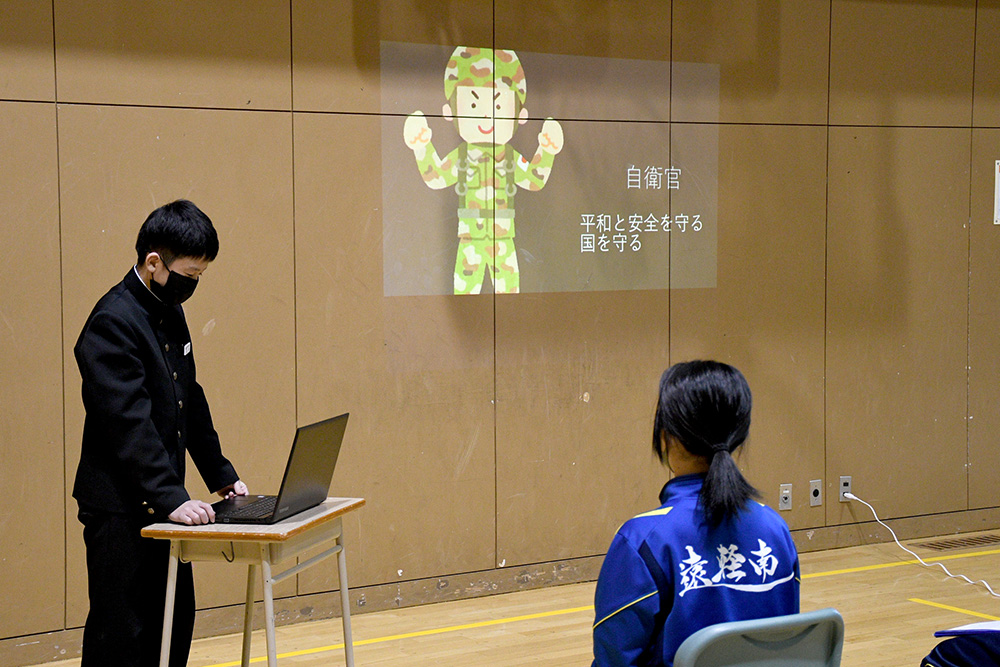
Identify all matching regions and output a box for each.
[212,413,348,524]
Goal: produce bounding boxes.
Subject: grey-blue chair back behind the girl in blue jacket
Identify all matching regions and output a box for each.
[674,609,844,667]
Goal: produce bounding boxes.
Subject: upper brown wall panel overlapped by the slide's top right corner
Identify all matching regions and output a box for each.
[672,0,830,123]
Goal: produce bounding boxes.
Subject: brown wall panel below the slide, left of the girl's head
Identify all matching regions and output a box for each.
[496,290,670,566]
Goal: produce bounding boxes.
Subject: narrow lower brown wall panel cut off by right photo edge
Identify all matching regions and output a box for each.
[969,130,1000,507]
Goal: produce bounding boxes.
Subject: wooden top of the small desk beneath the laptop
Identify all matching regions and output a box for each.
[142,498,365,542]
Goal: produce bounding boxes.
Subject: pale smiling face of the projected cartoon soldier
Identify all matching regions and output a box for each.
[445,86,528,146]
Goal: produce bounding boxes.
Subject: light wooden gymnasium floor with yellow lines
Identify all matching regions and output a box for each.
[29,531,1000,667]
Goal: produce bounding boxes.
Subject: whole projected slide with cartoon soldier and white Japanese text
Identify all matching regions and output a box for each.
[381,42,718,296]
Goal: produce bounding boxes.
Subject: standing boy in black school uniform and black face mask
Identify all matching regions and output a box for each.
[73,200,247,667]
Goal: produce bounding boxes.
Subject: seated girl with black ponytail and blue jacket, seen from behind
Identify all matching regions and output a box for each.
[594,361,799,667]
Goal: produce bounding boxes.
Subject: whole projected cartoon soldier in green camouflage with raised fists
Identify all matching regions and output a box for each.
[403,46,563,294]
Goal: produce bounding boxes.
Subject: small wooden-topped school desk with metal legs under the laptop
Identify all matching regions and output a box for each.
[142,498,365,667]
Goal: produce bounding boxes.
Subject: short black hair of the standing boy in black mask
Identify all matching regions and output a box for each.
[135,199,219,264]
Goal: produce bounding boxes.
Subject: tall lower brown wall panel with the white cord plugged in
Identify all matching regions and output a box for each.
[826,128,970,524]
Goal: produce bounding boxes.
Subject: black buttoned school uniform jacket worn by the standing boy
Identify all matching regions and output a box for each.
[73,269,239,521]
